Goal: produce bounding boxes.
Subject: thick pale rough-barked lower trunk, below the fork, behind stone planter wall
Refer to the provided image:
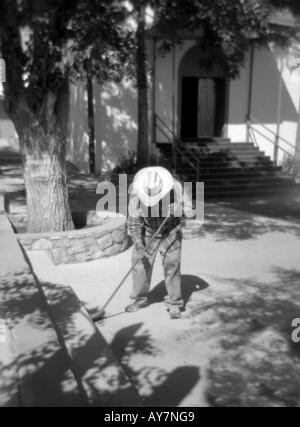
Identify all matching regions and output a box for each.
[14,89,74,233]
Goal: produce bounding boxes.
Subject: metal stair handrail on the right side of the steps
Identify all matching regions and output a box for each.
[247,115,300,177]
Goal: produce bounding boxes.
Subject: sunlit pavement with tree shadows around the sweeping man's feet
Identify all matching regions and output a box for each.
[59,205,300,406]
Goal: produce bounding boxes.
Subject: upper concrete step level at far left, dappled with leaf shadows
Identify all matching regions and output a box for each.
[0,214,83,406]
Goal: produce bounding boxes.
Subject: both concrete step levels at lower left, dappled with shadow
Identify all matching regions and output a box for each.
[0,214,142,407]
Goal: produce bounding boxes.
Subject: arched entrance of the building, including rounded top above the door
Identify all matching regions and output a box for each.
[178,44,228,139]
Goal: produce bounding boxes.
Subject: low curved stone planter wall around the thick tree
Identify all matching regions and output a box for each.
[17,217,129,264]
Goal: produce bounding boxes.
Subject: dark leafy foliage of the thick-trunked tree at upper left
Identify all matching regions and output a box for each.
[0,0,128,117]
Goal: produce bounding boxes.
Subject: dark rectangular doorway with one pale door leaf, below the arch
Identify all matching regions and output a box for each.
[181,77,226,139]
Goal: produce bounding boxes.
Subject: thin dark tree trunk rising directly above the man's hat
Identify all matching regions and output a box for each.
[136,5,149,168]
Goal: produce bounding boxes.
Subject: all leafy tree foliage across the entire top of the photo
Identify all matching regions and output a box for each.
[0,0,300,110]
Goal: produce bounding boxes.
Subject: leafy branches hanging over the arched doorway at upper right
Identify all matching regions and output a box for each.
[150,0,300,77]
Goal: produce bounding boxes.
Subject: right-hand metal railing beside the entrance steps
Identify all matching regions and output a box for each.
[247,115,300,177]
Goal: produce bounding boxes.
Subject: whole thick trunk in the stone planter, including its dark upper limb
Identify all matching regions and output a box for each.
[1,1,73,233]
